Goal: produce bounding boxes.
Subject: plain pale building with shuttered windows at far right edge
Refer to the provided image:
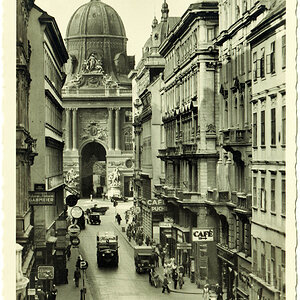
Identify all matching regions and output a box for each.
[247,1,287,299]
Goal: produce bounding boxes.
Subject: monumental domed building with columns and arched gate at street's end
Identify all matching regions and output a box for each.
[63,0,134,197]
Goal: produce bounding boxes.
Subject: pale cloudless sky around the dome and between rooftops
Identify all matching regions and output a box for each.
[35,0,197,64]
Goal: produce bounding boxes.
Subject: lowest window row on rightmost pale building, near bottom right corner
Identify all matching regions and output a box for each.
[252,238,286,292]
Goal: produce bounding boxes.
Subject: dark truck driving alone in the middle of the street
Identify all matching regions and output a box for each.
[97,232,119,268]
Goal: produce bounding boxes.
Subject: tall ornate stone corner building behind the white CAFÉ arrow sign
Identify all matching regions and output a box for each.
[154,1,218,287]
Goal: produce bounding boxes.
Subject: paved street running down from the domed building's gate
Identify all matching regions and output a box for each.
[57,200,202,300]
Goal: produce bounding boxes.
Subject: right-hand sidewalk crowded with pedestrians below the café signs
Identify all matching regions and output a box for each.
[113,215,214,299]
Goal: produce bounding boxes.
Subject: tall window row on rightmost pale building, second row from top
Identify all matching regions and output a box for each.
[252,105,286,147]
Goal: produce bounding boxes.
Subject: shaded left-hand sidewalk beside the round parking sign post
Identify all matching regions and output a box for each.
[56,248,93,300]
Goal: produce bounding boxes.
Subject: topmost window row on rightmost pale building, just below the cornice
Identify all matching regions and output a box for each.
[253,35,286,81]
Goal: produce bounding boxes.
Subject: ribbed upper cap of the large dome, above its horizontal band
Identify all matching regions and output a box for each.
[66,0,126,39]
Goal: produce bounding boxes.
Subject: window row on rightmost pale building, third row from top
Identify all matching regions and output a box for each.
[252,173,286,215]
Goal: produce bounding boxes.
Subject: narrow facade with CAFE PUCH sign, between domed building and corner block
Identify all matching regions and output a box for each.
[131,1,180,242]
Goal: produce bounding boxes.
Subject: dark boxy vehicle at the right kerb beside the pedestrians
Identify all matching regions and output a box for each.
[134,246,154,273]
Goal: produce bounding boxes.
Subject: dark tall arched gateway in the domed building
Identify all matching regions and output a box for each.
[80,142,106,197]
